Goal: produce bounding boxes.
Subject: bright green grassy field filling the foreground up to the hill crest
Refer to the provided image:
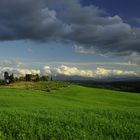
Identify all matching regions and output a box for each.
[0,82,140,140]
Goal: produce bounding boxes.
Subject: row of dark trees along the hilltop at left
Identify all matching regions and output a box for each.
[1,72,52,84]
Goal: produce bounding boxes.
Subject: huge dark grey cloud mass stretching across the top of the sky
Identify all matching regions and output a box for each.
[0,0,140,56]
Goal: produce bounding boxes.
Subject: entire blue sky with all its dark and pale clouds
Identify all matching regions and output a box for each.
[0,0,140,79]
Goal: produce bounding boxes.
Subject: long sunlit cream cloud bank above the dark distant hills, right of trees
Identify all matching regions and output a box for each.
[56,65,138,78]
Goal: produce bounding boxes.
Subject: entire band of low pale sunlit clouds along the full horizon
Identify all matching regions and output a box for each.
[0,65,140,79]
